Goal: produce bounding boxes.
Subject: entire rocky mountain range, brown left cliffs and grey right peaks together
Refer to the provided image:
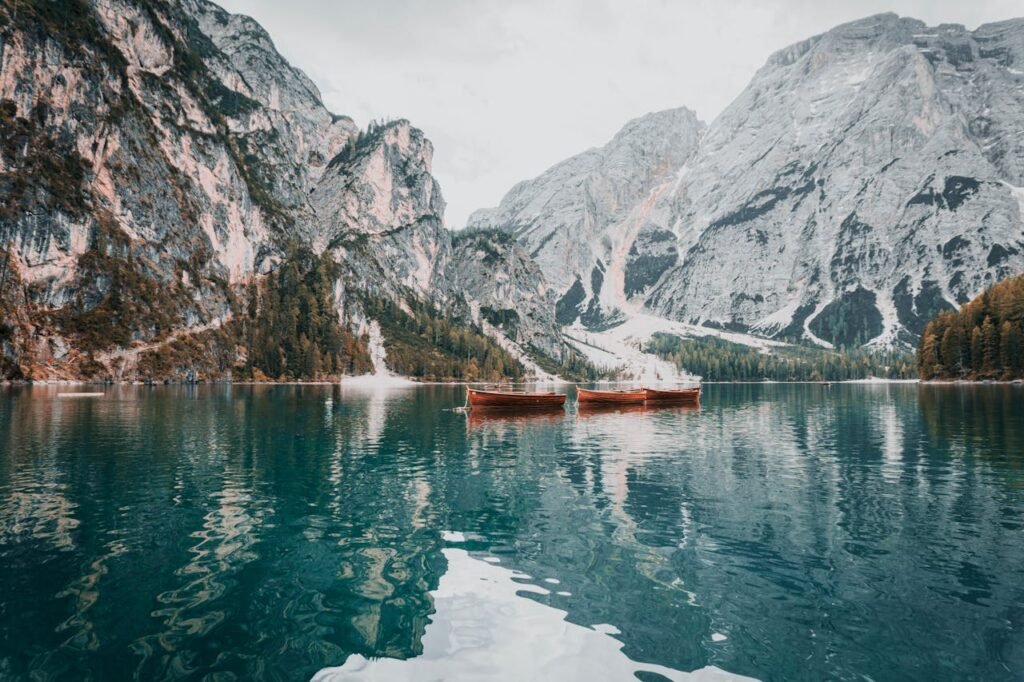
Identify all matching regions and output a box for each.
[0,0,1024,379]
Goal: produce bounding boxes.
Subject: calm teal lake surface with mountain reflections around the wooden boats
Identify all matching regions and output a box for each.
[0,385,1024,680]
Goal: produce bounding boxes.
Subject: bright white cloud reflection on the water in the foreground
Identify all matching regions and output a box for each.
[313,548,750,682]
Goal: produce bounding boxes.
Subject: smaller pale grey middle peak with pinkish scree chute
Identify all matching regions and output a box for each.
[469,109,705,325]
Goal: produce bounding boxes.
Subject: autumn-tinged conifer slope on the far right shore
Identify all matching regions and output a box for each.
[918,274,1024,380]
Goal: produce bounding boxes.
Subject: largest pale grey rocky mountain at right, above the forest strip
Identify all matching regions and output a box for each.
[647,14,1024,345]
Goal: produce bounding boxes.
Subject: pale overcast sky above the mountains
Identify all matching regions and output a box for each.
[219,0,1024,228]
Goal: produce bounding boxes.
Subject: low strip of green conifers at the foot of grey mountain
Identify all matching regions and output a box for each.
[646,334,914,381]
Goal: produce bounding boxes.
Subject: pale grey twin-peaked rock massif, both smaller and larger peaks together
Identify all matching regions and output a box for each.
[471,14,1024,346]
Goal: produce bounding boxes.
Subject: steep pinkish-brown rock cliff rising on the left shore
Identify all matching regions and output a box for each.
[0,0,552,379]
